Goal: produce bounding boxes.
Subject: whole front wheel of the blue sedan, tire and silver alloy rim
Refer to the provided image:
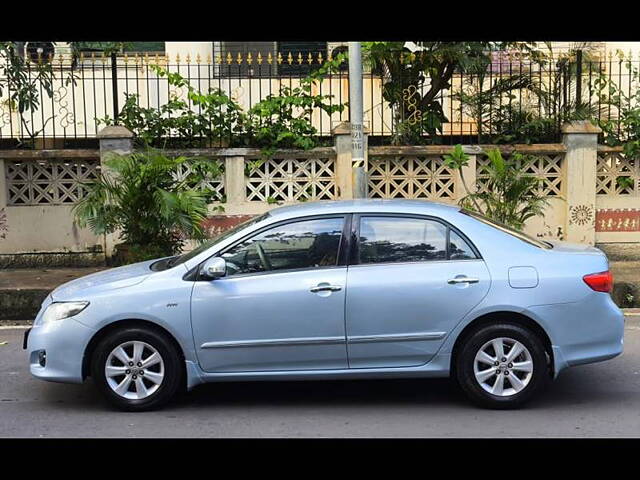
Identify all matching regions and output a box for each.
[91,327,184,411]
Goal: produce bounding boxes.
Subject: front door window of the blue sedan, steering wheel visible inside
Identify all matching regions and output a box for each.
[222,217,344,275]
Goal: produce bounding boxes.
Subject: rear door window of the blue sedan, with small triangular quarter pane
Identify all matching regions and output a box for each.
[359,216,477,264]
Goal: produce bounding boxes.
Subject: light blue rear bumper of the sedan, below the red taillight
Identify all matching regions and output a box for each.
[529,293,624,377]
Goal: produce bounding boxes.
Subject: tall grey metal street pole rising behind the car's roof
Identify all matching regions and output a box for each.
[349,42,367,198]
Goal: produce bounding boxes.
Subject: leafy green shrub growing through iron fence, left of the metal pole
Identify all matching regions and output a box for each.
[97,54,346,157]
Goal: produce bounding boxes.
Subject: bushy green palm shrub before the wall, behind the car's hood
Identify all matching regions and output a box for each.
[74,149,221,262]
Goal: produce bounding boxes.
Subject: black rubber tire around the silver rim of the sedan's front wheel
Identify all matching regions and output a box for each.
[91,327,185,412]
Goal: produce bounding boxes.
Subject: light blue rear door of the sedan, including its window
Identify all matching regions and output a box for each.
[345,214,490,368]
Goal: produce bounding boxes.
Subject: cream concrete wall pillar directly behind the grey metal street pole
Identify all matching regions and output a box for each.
[331,122,369,200]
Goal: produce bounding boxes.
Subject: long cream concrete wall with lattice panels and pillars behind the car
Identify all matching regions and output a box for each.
[0,120,640,264]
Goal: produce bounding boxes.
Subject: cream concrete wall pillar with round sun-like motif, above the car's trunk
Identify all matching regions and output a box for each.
[562,120,602,245]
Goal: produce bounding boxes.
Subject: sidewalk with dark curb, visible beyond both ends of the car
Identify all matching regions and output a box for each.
[0,261,640,325]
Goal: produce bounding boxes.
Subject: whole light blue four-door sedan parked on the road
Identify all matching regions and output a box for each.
[25,200,624,410]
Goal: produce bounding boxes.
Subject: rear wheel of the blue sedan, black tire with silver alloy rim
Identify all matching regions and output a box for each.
[456,324,549,409]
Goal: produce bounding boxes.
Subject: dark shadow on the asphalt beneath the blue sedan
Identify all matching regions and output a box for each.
[33,366,624,411]
